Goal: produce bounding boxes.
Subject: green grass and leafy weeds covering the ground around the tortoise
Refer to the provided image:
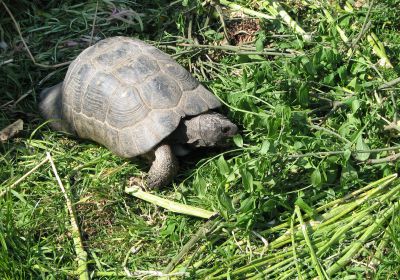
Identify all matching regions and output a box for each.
[0,0,400,279]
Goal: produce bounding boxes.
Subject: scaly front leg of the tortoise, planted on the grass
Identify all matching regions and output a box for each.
[146,143,178,189]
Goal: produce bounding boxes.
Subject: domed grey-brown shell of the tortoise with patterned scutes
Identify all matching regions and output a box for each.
[62,37,221,158]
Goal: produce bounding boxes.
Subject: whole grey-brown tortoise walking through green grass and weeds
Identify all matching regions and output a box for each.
[39,37,237,188]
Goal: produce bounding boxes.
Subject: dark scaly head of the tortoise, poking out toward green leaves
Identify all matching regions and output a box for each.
[184,112,238,147]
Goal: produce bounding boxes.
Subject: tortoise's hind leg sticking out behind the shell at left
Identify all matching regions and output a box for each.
[39,82,75,134]
